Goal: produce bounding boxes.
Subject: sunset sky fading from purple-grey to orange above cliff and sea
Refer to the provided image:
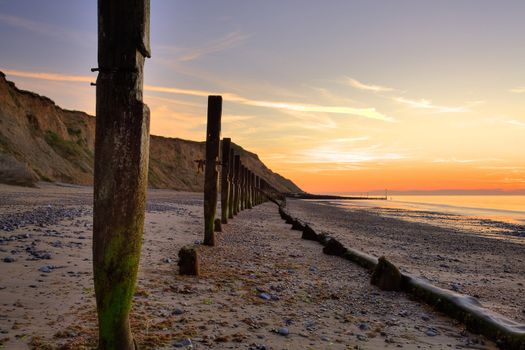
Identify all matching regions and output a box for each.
[0,0,525,193]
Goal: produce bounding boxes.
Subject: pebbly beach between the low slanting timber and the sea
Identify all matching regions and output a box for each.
[288,200,525,323]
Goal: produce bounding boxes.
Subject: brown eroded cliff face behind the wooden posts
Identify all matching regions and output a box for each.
[0,72,301,192]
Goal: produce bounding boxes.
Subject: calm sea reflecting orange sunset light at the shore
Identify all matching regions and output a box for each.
[323,195,525,243]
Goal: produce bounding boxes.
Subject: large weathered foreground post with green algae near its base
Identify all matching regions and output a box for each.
[93,0,151,350]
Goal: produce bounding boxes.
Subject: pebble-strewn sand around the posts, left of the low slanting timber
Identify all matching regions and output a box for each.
[0,185,498,350]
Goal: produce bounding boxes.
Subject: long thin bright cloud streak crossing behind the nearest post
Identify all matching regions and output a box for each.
[3,69,395,122]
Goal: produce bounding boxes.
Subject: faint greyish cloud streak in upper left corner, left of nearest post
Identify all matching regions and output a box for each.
[0,13,96,44]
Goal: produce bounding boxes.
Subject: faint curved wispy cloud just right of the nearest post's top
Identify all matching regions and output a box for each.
[158,32,250,62]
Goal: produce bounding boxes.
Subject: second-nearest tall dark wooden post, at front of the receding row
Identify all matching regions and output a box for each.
[203,96,222,246]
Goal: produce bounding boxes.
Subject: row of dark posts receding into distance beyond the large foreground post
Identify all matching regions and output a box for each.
[203,96,278,246]
